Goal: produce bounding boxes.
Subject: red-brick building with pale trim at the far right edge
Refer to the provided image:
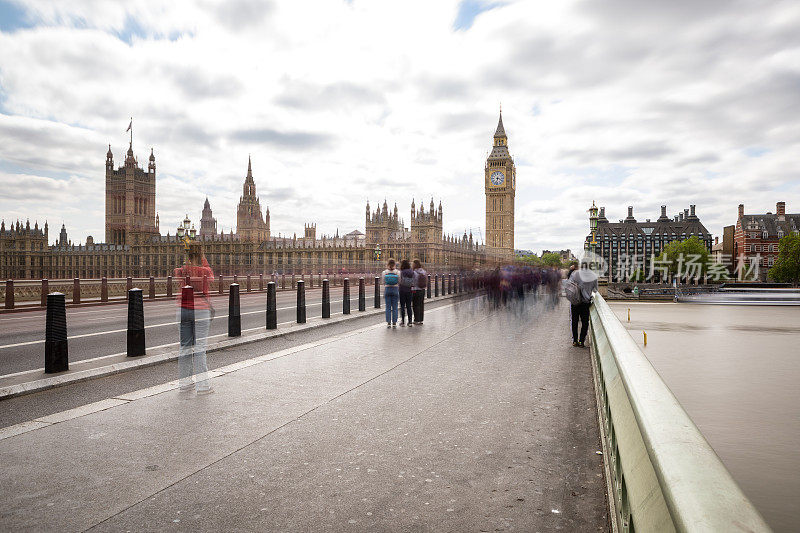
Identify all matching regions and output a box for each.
[736,202,800,280]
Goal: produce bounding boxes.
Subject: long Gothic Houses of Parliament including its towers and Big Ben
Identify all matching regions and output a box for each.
[0,112,516,279]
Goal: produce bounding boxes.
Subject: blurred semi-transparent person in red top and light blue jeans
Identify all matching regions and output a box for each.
[173,242,214,395]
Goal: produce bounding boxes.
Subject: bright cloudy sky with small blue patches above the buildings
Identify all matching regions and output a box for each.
[0,0,800,252]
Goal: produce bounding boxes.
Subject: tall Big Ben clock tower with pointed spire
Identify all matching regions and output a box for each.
[484,110,517,261]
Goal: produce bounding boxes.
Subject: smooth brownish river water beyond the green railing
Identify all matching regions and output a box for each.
[609,301,800,532]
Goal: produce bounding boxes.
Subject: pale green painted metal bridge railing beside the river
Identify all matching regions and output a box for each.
[591,293,771,532]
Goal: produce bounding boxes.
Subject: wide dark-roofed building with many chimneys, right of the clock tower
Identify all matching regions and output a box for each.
[584,204,712,281]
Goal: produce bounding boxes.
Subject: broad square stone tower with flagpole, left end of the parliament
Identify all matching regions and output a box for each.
[105,141,158,245]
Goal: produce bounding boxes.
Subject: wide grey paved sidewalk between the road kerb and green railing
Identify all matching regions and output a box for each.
[0,300,608,531]
